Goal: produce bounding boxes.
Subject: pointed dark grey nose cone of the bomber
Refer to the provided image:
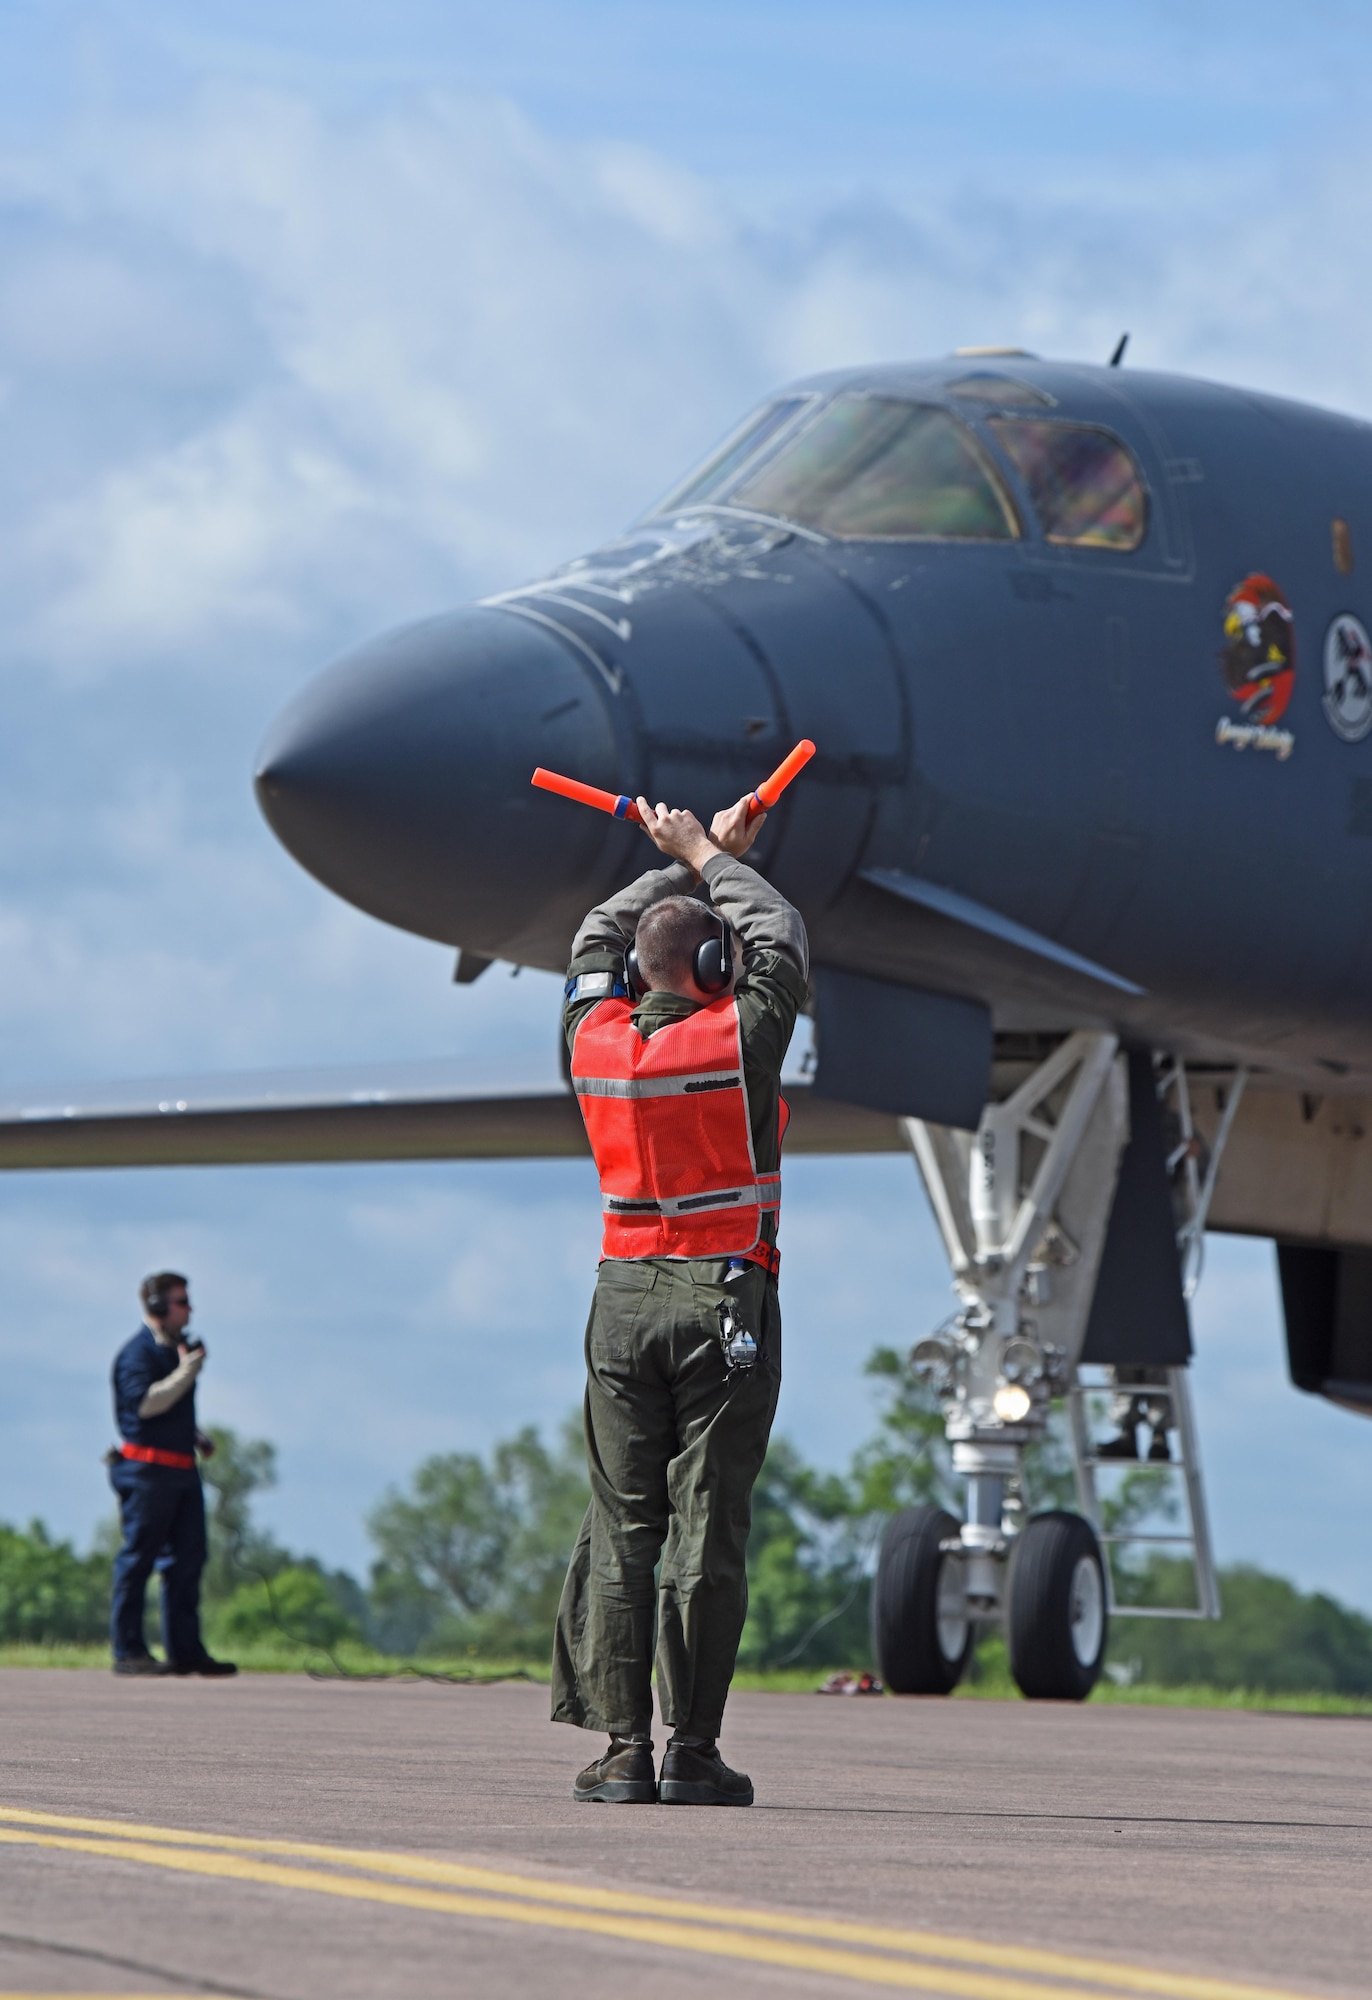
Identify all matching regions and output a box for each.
[256,608,620,966]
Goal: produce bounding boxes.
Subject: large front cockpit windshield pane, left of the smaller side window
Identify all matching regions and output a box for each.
[728,394,1020,542]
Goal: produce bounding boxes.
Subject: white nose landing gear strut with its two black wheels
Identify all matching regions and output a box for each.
[872,1032,1128,1700]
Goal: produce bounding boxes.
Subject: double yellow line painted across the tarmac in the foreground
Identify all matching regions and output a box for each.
[0,1806,1336,2000]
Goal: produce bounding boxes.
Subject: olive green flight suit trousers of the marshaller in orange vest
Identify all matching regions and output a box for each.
[552,1258,782,1738]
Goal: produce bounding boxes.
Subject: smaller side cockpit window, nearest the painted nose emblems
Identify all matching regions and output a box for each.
[990,416,1148,550]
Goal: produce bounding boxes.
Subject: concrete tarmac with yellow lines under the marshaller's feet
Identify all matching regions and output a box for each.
[0,1670,1372,2000]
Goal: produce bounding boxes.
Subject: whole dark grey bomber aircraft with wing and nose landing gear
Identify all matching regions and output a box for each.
[10,350,1372,1698]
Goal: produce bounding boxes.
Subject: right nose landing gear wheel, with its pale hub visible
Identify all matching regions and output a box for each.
[1006,1512,1108,1702]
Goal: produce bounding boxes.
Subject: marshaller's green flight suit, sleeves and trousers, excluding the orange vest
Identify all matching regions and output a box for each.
[552,856,808,1738]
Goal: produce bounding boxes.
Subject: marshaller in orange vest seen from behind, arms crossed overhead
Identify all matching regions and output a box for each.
[552,798,810,1806]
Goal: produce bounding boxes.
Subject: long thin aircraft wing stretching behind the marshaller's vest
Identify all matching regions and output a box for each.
[0,1058,906,1172]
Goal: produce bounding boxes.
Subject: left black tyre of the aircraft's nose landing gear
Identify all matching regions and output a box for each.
[872,1506,976,1694]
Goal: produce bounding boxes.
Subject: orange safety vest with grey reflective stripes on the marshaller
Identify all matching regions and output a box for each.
[572,994,790,1272]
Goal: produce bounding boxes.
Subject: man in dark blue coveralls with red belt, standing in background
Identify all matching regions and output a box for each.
[110,1270,238,1676]
